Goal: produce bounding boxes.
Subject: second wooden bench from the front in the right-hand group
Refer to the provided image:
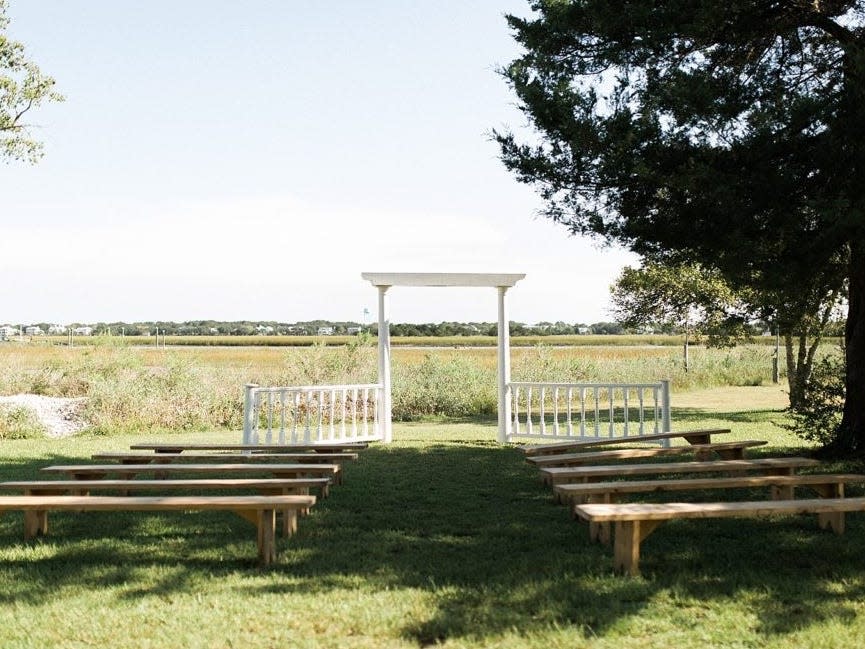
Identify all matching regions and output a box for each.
[554,473,865,543]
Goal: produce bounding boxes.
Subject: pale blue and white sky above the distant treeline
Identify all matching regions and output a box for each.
[0,0,636,324]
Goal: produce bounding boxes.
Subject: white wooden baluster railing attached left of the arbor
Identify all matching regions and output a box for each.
[243,384,384,444]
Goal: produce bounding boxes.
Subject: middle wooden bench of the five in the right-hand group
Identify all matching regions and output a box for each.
[541,457,820,487]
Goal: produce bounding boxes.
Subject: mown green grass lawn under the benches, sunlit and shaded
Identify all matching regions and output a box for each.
[0,388,865,649]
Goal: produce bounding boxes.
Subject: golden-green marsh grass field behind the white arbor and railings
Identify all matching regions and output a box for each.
[0,336,773,438]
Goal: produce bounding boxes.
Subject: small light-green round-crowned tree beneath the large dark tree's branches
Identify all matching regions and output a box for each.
[610,262,749,372]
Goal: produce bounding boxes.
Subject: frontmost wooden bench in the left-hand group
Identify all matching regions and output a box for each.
[0,496,315,566]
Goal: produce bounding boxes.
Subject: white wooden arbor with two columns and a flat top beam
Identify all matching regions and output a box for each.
[361,273,525,443]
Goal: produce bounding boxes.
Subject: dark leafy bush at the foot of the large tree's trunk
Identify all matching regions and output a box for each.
[788,354,846,446]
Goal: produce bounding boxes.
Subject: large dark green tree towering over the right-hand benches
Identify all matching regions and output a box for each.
[493,0,865,453]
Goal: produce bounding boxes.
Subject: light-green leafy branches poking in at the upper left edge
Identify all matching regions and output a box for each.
[0,0,63,162]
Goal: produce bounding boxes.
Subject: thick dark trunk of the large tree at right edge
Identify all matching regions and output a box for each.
[830,241,865,455]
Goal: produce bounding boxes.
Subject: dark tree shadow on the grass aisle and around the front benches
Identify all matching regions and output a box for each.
[0,441,865,646]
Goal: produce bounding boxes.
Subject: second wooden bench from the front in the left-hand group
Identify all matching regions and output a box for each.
[0,478,330,536]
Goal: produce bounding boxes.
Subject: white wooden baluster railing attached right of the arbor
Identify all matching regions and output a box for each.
[508,381,670,441]
